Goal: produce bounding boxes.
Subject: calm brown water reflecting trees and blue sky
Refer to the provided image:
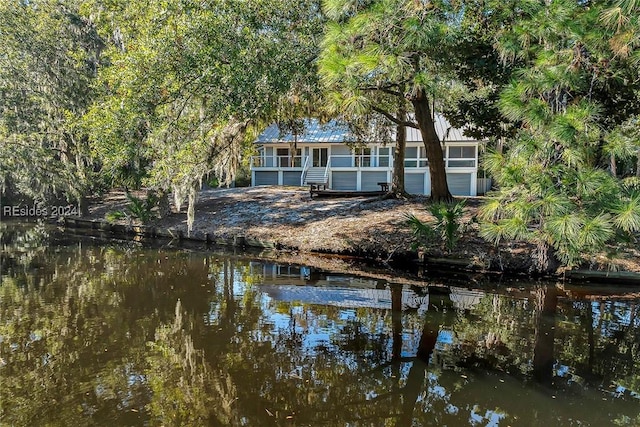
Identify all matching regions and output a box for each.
[0,224,640,427]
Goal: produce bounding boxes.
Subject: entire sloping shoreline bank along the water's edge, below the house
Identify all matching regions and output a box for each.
[43,187,640,286]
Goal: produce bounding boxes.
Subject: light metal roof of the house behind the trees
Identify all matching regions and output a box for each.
[256,113,476,144]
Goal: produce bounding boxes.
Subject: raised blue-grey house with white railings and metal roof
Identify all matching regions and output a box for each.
[251,115,485,196]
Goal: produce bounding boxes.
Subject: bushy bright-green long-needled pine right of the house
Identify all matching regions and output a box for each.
[481,1,640,272]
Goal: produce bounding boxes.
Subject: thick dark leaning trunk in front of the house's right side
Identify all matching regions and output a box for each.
[411,90,453,202]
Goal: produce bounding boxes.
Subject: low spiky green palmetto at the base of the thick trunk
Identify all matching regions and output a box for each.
[405,200,465,251]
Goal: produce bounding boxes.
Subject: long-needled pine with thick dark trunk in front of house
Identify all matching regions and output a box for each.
[319,0,454,201]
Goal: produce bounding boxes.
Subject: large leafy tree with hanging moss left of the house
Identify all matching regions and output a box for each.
[83,0,322,231]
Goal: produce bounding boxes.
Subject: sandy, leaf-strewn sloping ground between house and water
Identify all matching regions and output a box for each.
[89,187,640,271]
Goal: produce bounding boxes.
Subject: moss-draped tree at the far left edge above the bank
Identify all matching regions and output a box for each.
[0,0,103,208]
